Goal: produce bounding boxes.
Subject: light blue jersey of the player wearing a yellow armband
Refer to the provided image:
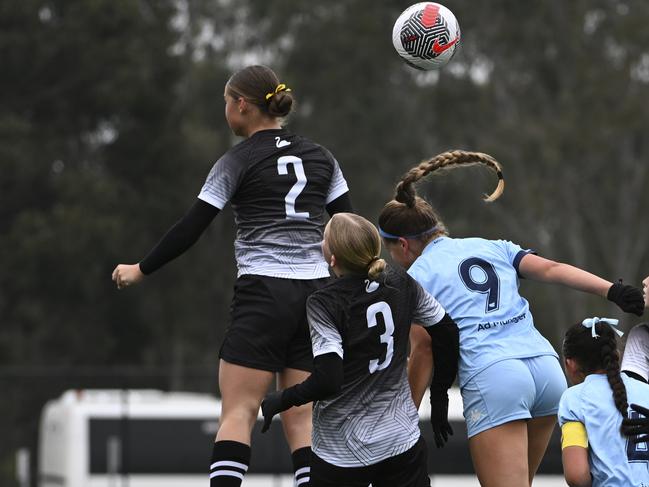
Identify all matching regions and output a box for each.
[559,374,649,487]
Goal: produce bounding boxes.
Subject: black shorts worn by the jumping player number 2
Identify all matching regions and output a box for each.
[220,274,330,372]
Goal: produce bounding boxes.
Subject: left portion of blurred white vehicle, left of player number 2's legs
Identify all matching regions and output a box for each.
[38,390,221,487]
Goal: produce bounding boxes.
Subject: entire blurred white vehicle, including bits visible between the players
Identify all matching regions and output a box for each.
[38,389,565,487]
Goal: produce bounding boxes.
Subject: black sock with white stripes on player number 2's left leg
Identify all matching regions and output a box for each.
[210,440,250,487]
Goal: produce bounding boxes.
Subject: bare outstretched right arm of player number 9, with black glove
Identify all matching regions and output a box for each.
[518,254,644,316]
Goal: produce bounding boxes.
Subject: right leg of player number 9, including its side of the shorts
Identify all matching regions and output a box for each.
[523,355,568,485]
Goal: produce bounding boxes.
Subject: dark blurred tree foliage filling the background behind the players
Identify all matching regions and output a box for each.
[0,0,649,485]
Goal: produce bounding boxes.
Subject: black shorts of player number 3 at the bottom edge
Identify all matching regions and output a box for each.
[309,437,430,487]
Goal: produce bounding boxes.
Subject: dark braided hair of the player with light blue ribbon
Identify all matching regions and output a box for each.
[563,323,629,430]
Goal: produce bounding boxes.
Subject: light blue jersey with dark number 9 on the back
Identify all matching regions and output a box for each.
[408,237,558,387]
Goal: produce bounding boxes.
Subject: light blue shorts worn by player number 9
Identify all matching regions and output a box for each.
[462,355,567,438]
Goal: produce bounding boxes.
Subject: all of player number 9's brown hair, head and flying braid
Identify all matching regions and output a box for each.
[379,150,505,240]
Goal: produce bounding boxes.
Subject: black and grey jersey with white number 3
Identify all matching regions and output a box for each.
[307,267,445,467]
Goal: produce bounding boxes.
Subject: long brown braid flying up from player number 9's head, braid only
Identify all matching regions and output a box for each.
[394,150,505,208]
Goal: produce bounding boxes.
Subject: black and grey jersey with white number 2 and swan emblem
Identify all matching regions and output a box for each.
[198,129,348,279]
